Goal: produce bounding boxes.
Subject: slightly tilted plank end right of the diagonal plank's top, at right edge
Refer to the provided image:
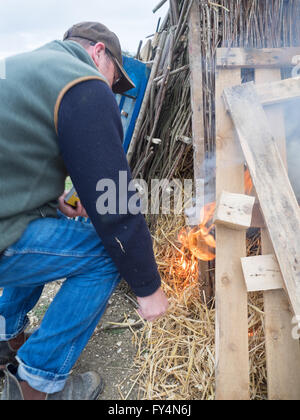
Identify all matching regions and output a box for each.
[256,77,300,105]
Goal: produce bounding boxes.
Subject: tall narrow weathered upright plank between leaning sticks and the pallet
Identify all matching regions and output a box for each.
[189,1,212,300]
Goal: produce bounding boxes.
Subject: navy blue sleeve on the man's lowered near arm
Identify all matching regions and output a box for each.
[58,80,161,297]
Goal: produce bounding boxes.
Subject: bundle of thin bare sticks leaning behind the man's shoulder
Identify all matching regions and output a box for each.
[128,0,193,192]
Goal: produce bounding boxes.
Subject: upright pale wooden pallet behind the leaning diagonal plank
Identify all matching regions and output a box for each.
[216,48,300,400]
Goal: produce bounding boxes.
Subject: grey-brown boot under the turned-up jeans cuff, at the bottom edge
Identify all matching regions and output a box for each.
[1,365,104,401]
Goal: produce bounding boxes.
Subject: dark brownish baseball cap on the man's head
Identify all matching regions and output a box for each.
[63,22,135,93]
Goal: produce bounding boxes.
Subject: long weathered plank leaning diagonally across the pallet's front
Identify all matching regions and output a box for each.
[224,83,300,315]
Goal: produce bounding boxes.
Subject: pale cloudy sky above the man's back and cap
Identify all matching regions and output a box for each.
[0,0,169,58]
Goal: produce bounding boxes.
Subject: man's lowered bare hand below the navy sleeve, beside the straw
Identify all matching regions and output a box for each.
[137,288,169,321]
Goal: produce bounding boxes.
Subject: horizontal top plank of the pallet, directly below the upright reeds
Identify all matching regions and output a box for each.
[217,47,300,68]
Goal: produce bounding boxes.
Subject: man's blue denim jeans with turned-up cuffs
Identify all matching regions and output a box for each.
[0,216,120,393]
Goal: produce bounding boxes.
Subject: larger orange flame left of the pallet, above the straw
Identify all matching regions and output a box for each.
[178,203,216,267]
